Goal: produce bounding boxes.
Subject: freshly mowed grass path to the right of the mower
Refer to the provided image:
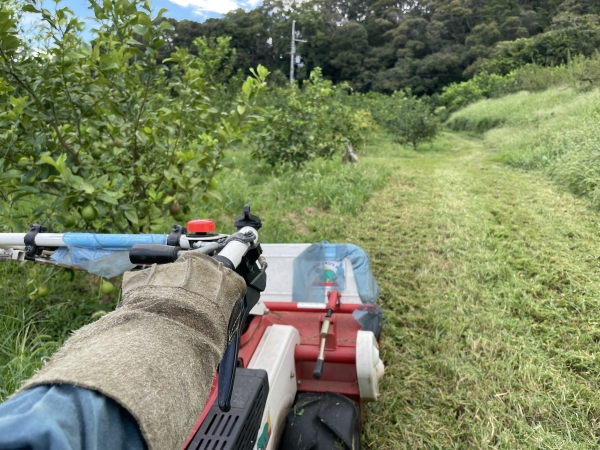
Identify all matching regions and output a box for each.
[350,135,600,450]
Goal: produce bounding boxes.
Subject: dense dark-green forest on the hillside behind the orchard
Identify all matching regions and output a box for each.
[165,0,600,95]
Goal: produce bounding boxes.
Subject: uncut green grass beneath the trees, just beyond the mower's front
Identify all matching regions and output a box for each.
[204,136,410,242]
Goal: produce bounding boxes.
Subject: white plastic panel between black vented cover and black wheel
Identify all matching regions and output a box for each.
[248,325,300,450]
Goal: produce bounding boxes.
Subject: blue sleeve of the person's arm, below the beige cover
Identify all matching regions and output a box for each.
[0,385,146,450]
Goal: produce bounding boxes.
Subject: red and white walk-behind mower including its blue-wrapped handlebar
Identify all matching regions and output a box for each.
[0,205,384,450]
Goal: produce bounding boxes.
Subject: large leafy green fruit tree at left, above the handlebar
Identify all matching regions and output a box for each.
[0,0,267,232]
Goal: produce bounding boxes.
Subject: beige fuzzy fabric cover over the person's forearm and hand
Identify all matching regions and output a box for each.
[17,255,246,450]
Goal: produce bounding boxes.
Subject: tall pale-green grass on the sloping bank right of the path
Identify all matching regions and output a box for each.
[448,87,600,208]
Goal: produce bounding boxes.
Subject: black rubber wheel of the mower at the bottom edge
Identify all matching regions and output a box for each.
[279,392,360,450]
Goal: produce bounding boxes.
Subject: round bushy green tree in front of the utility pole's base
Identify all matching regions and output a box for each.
[253,69,373,167]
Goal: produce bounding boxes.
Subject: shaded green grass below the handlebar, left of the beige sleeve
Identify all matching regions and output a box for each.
[0,262,117,402]
